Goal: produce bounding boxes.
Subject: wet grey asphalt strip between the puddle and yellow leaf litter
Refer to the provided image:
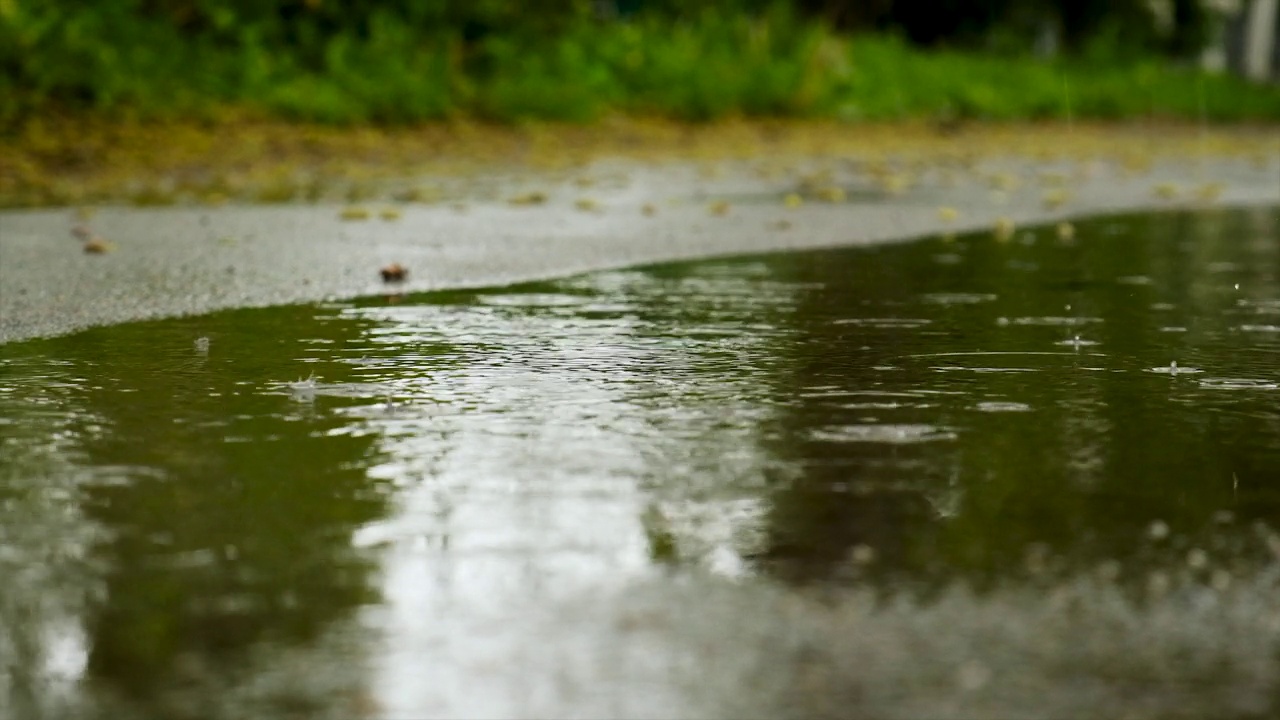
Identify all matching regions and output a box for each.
[0,155,1280,342]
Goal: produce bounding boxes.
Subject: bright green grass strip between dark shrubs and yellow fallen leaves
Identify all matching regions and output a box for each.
[0,0,1280,124]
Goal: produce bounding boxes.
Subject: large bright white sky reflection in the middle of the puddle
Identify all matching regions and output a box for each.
[337,267,786,717]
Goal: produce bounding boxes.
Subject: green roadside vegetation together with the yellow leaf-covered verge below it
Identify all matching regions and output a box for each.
[0,0,1280,208]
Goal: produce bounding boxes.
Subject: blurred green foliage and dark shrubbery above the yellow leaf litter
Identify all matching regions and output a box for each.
[0,0,1280,124]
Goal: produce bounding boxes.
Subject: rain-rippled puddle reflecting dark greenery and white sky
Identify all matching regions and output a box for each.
[0,204,1280,717]
